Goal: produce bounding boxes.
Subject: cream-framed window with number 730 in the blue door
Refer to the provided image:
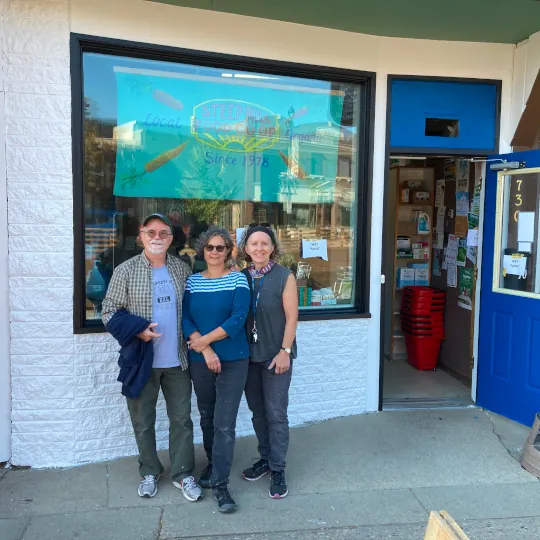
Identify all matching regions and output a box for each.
[493,169,540,297]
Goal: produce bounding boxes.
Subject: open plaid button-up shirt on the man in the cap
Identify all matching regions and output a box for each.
[102,252,191,370]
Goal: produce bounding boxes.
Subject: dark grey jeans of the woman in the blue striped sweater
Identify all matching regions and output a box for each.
[190,359,248,485]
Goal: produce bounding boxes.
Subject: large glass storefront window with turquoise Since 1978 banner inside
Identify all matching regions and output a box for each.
[75,39,372,326]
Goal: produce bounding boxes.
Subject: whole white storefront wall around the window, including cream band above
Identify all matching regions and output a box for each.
[5,0,513,466]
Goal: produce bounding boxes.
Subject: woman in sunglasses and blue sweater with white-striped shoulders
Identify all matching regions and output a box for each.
[182,228,250,513]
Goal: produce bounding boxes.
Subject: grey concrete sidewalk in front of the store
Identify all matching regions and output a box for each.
[0,409,540,540]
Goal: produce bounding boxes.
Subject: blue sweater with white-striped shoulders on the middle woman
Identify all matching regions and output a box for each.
[182,272,251,361]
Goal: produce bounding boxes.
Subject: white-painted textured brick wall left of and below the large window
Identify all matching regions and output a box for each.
[2,0,370,467]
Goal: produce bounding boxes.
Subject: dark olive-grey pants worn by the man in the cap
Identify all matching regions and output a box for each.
[127,367,195,481]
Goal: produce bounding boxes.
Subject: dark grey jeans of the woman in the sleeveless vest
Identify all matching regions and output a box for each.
[246,361,292,471]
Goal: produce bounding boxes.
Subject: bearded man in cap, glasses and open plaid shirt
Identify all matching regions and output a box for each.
[102,214,203,501]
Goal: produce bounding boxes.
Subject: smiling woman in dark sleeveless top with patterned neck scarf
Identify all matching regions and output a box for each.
[240,225,298,499]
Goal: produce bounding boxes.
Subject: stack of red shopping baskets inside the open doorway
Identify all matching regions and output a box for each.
[401,287,446,370]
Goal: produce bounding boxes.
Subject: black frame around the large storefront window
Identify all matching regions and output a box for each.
[70,33,375,334]
